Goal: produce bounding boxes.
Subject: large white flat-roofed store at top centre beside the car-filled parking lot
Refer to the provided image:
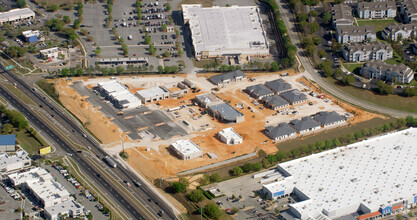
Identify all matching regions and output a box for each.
[182,4,269,58]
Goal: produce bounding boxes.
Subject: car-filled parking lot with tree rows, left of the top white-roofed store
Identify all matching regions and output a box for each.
[83,0,187,67]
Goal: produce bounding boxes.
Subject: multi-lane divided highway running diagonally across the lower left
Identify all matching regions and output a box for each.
[0,66,176,219]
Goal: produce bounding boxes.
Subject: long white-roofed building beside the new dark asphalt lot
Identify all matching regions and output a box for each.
[98,80,142,109]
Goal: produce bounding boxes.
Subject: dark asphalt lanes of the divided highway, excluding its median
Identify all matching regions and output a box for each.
[0,67,176,219]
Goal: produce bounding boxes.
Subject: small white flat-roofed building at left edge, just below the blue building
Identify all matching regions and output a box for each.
[0,150,32,174]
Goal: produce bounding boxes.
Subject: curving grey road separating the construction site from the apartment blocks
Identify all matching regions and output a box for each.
[276,0,417,118]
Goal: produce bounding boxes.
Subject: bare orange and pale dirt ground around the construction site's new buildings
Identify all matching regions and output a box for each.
[57,70,380,182]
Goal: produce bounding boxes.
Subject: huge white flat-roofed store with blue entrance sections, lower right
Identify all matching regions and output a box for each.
[263,128,417,219]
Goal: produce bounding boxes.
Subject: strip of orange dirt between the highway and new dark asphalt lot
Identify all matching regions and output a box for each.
[55,79,120,144]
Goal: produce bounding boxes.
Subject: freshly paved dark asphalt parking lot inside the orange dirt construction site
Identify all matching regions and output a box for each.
[71,81,187,140]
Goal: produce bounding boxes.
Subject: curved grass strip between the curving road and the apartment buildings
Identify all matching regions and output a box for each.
[325,77,417,113]
